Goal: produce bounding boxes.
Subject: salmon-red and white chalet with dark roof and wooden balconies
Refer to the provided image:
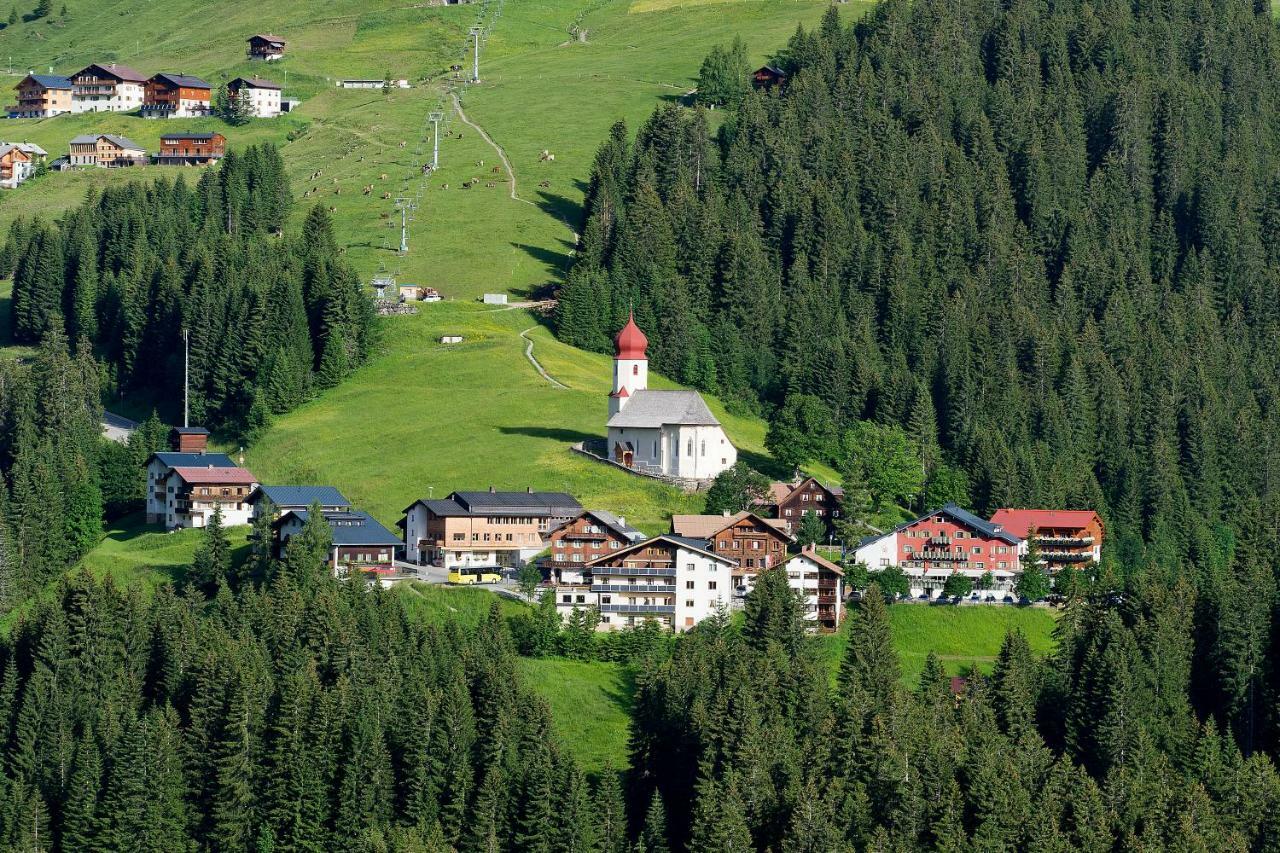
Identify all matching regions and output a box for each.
[855,503,1025,598]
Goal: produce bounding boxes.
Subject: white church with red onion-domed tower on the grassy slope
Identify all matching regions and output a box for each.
[608,316,737,480]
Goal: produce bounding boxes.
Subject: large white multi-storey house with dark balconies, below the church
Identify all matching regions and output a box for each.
[544,534,735,631]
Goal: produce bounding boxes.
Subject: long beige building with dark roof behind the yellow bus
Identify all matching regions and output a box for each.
[399,487,582,569]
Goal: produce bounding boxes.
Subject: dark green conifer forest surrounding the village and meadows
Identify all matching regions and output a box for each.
[0,0,1280,853]
